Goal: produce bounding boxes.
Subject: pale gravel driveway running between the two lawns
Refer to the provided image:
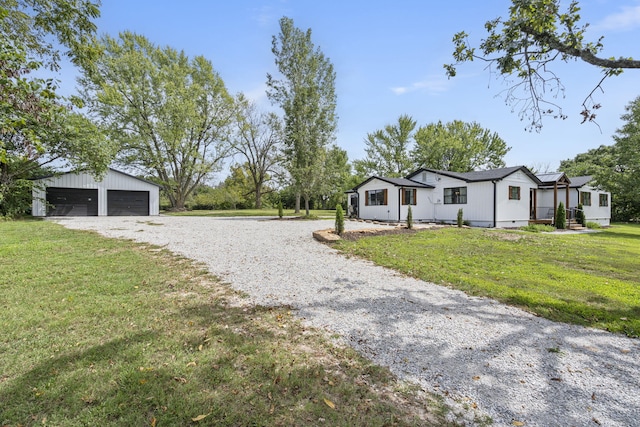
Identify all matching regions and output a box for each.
[59,217,640,426]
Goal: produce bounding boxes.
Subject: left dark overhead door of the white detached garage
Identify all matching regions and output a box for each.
[47,187,98,216]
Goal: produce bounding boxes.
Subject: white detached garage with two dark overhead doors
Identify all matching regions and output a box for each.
[32,169,160,216]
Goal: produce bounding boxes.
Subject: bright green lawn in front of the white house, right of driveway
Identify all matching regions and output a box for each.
[337,224,640,337]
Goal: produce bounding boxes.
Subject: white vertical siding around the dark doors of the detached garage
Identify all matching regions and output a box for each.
[32,169,160,216]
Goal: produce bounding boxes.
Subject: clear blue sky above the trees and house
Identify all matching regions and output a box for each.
[60,0,640,177]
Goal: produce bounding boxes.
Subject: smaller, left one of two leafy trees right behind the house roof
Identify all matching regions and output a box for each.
[354,114,416,177]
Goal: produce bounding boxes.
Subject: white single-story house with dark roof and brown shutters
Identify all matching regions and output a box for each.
[348,166,611,228]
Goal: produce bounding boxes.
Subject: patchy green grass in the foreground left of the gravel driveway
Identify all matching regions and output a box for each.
[0,221,447,426]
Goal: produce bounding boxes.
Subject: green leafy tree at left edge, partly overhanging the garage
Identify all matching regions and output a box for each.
[0,0,112,216]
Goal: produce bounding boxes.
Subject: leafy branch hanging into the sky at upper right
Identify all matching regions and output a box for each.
[444,0,640,131]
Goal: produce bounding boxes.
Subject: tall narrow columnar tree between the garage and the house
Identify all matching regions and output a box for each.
[267,17,337,215]
